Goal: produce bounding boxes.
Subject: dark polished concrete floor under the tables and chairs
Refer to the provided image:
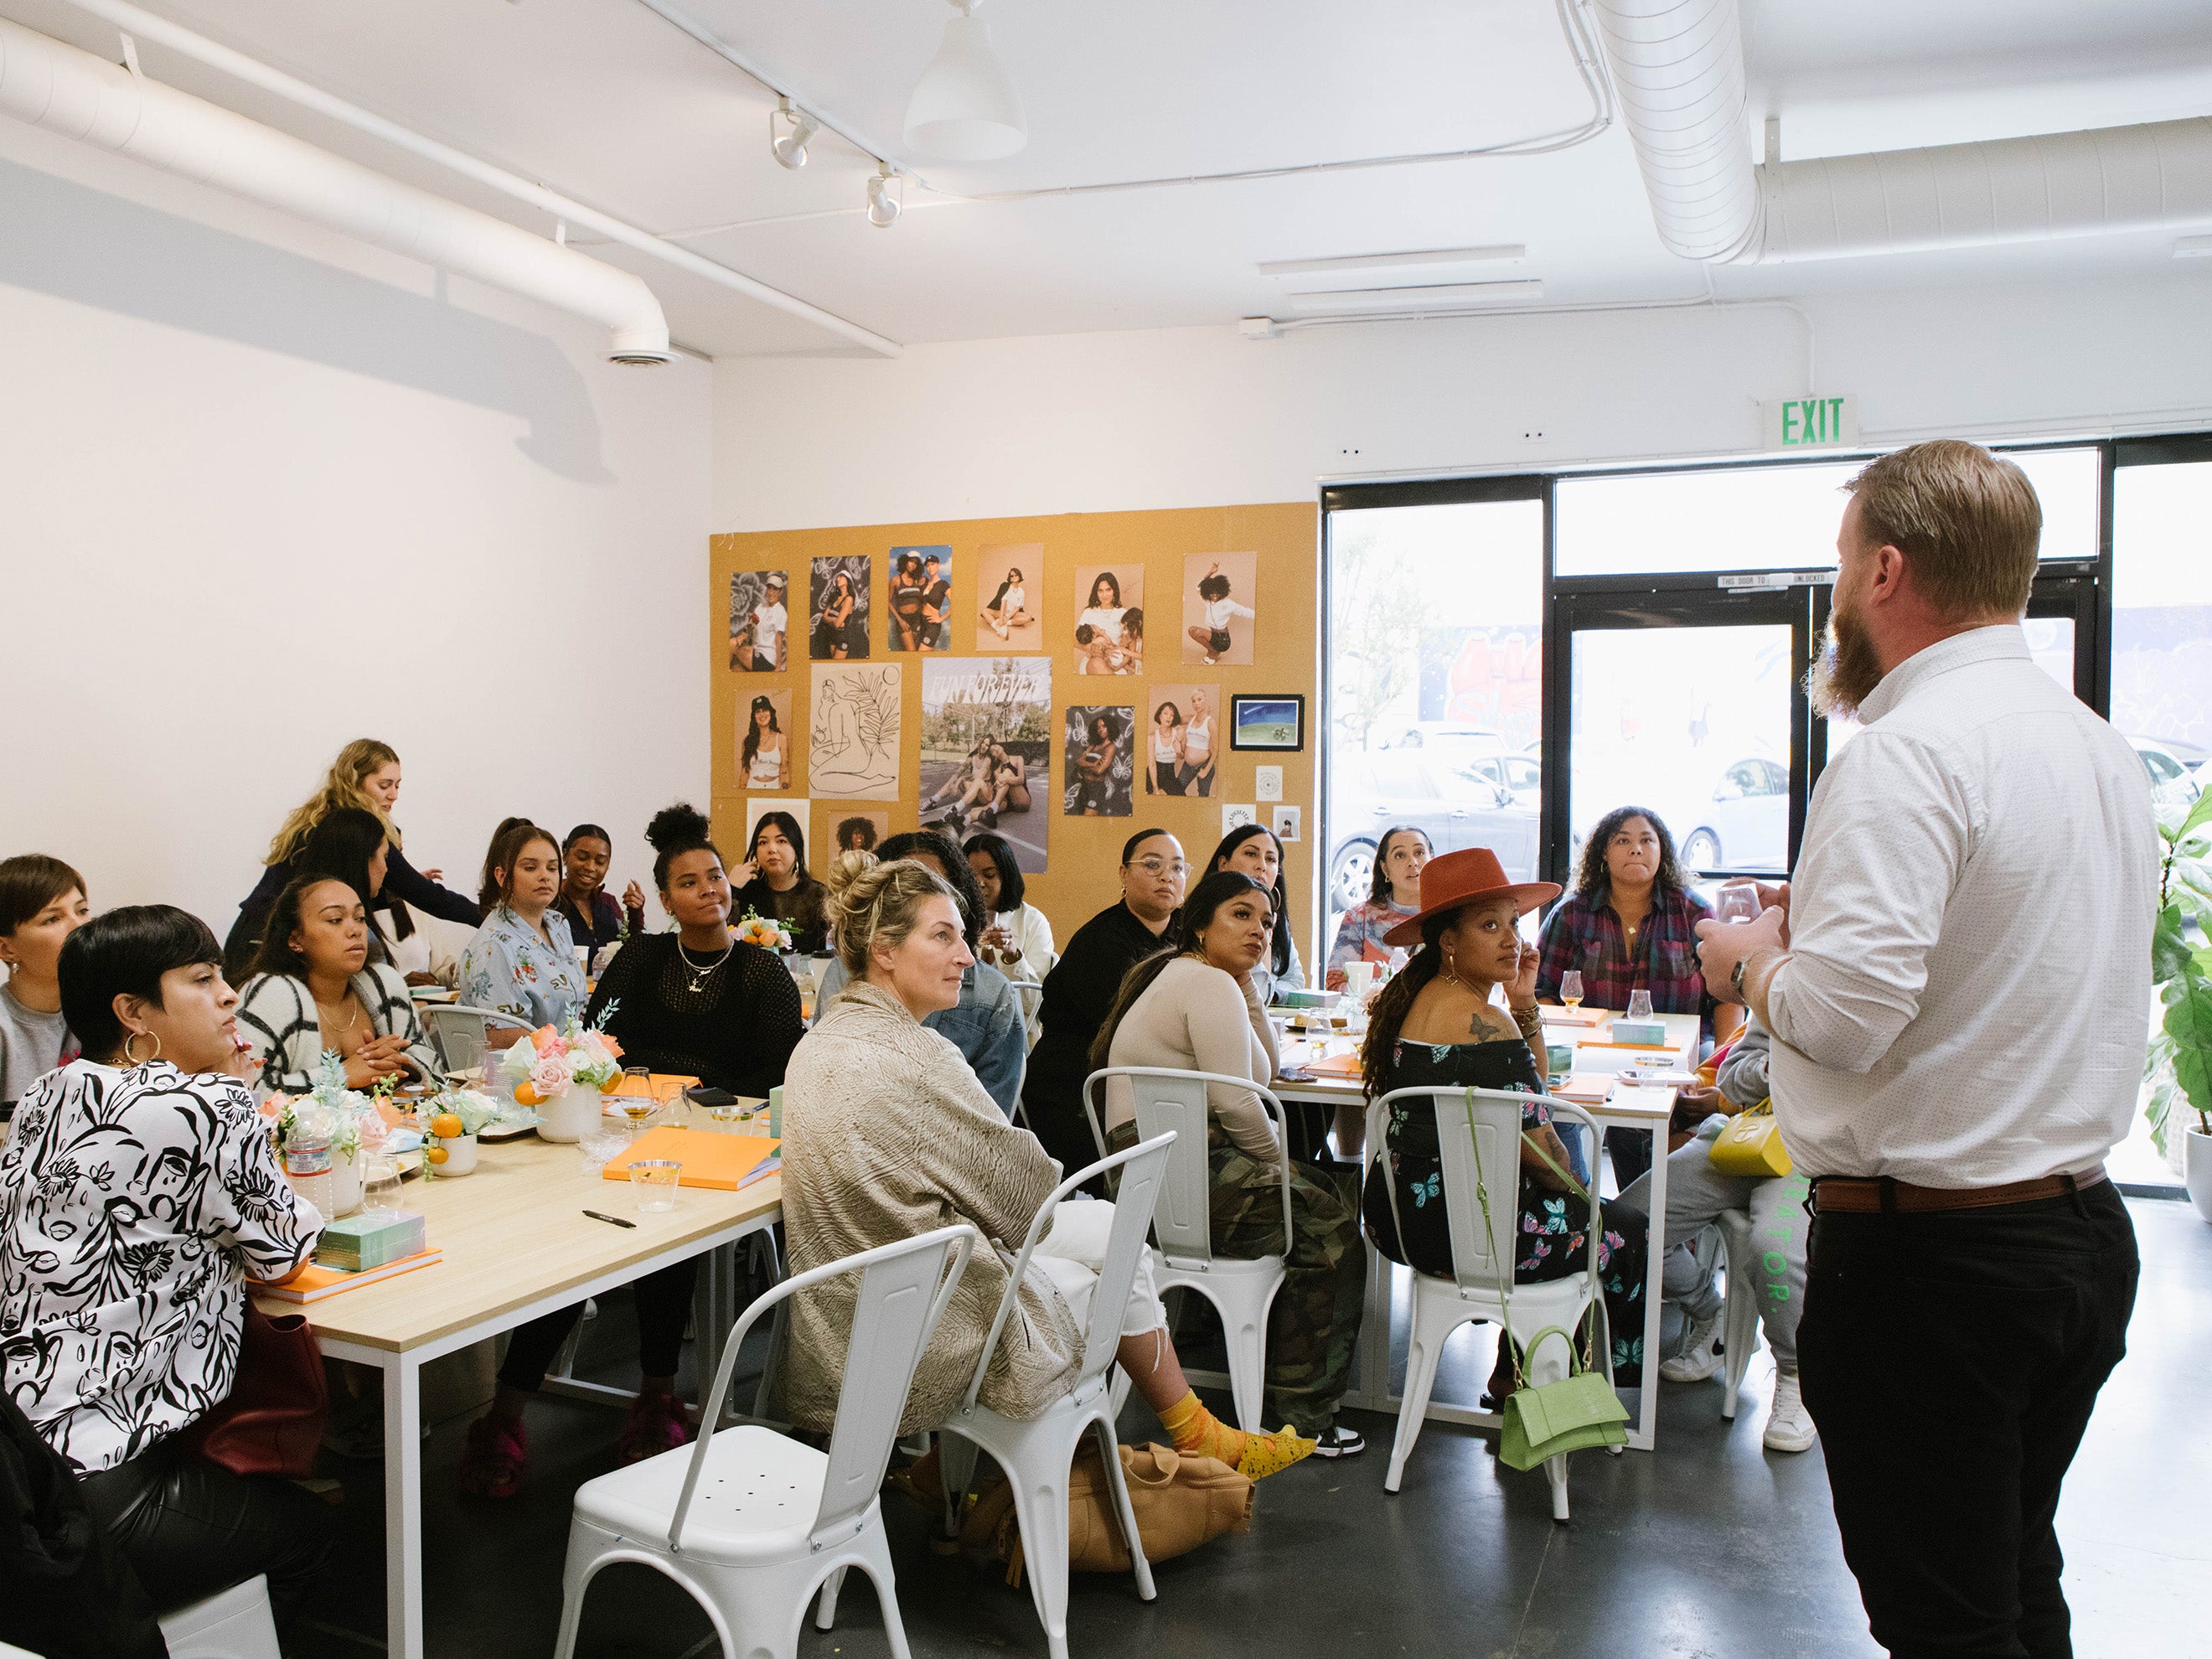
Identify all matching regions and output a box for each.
[301,1202,2212,1659]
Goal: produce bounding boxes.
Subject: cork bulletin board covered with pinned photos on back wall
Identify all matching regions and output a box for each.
[708,502,1320,974]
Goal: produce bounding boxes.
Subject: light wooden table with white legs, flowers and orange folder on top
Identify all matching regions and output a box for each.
[261,1134,783,1659]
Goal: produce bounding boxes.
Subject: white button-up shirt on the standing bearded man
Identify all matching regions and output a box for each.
[1767,626,2159,1188]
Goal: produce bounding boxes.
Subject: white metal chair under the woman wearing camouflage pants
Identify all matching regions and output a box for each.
[1084,1066,1289,1434]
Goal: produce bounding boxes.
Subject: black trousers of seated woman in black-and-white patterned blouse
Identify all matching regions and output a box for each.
[84,1440,339,1625]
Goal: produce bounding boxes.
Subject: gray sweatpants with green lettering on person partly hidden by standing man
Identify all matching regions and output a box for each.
[1621,1115,1811,1372]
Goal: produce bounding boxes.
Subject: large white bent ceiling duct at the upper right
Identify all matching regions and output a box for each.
[1597,0,2212,263]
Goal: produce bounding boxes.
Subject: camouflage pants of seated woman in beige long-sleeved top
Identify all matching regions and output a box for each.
[1106,1124,1367,1435]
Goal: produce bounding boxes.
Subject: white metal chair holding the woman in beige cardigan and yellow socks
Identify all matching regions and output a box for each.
[938,1134,1171,1659]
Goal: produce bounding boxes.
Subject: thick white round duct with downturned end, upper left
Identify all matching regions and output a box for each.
[0,18,670,363]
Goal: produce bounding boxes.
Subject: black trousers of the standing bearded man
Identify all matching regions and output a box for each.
[1798,1181,2137,1659]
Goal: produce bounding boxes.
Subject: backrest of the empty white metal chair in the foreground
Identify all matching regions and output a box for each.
[668,1223,977,1551]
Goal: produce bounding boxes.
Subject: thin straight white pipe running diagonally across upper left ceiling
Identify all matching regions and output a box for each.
[43,0,905,356]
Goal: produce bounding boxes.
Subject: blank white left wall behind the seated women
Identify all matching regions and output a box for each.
[0,121,710,933]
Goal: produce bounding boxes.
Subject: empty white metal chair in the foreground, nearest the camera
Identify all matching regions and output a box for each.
[556,1226,982,1659]
